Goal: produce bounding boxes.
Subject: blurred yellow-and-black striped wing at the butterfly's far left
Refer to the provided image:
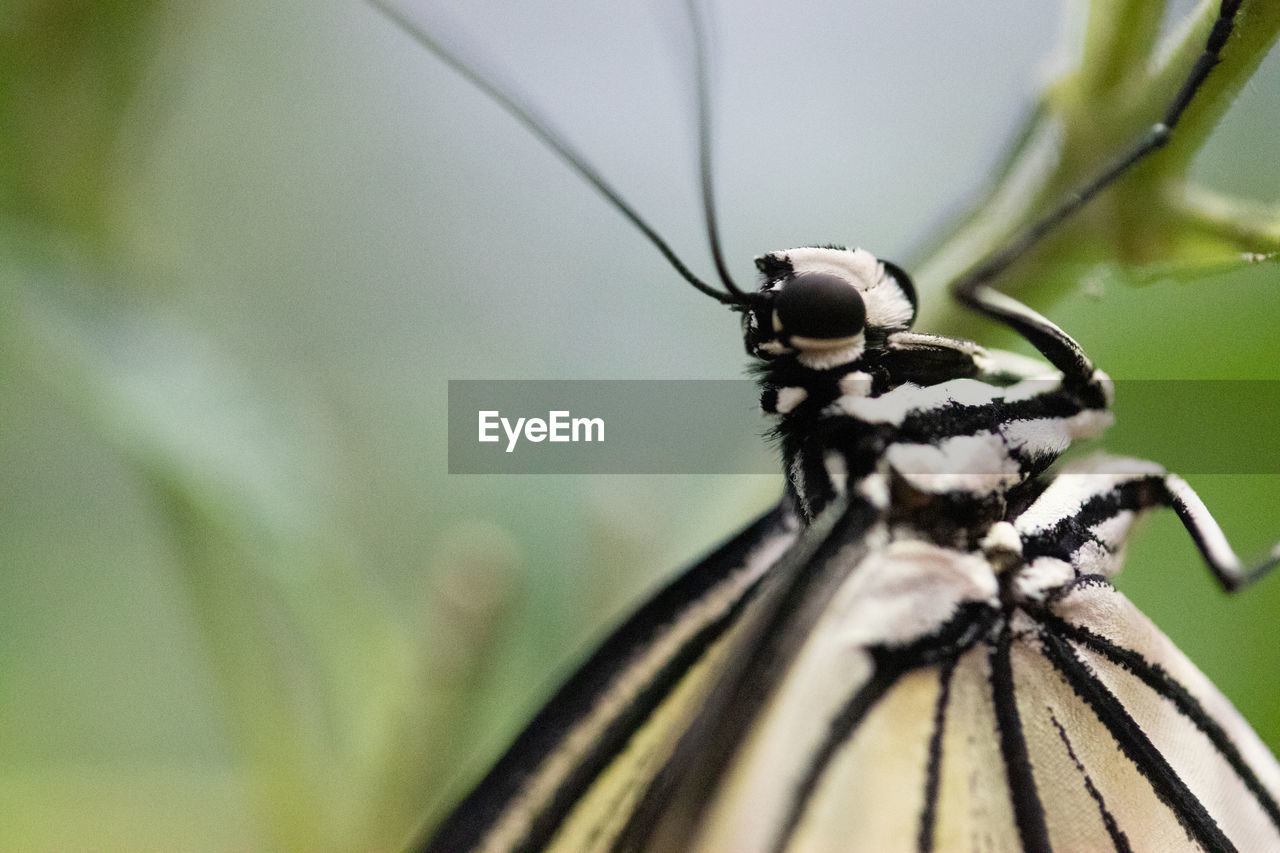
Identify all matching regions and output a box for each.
[420,501,799,853]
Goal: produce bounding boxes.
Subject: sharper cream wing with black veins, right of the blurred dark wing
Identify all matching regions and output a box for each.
[611,530,1280,853]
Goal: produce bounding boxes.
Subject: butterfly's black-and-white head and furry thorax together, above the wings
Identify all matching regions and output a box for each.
[745,247,1111,537]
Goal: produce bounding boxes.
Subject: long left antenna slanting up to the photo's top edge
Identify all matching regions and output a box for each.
[367,0,745,306]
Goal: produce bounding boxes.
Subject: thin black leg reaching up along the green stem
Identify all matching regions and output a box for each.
[951,0,1240,386]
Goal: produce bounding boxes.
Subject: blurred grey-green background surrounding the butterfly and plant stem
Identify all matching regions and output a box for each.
[0,0,1280,850]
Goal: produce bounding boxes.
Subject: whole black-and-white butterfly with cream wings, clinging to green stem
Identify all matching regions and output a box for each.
[373,0,1280,850]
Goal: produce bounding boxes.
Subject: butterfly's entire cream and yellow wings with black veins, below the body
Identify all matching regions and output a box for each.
[426,503,1280,853]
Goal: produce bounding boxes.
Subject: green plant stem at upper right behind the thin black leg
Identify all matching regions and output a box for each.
[914,0,1280,334]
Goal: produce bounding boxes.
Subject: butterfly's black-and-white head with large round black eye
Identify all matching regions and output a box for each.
[745,247,915,370]
